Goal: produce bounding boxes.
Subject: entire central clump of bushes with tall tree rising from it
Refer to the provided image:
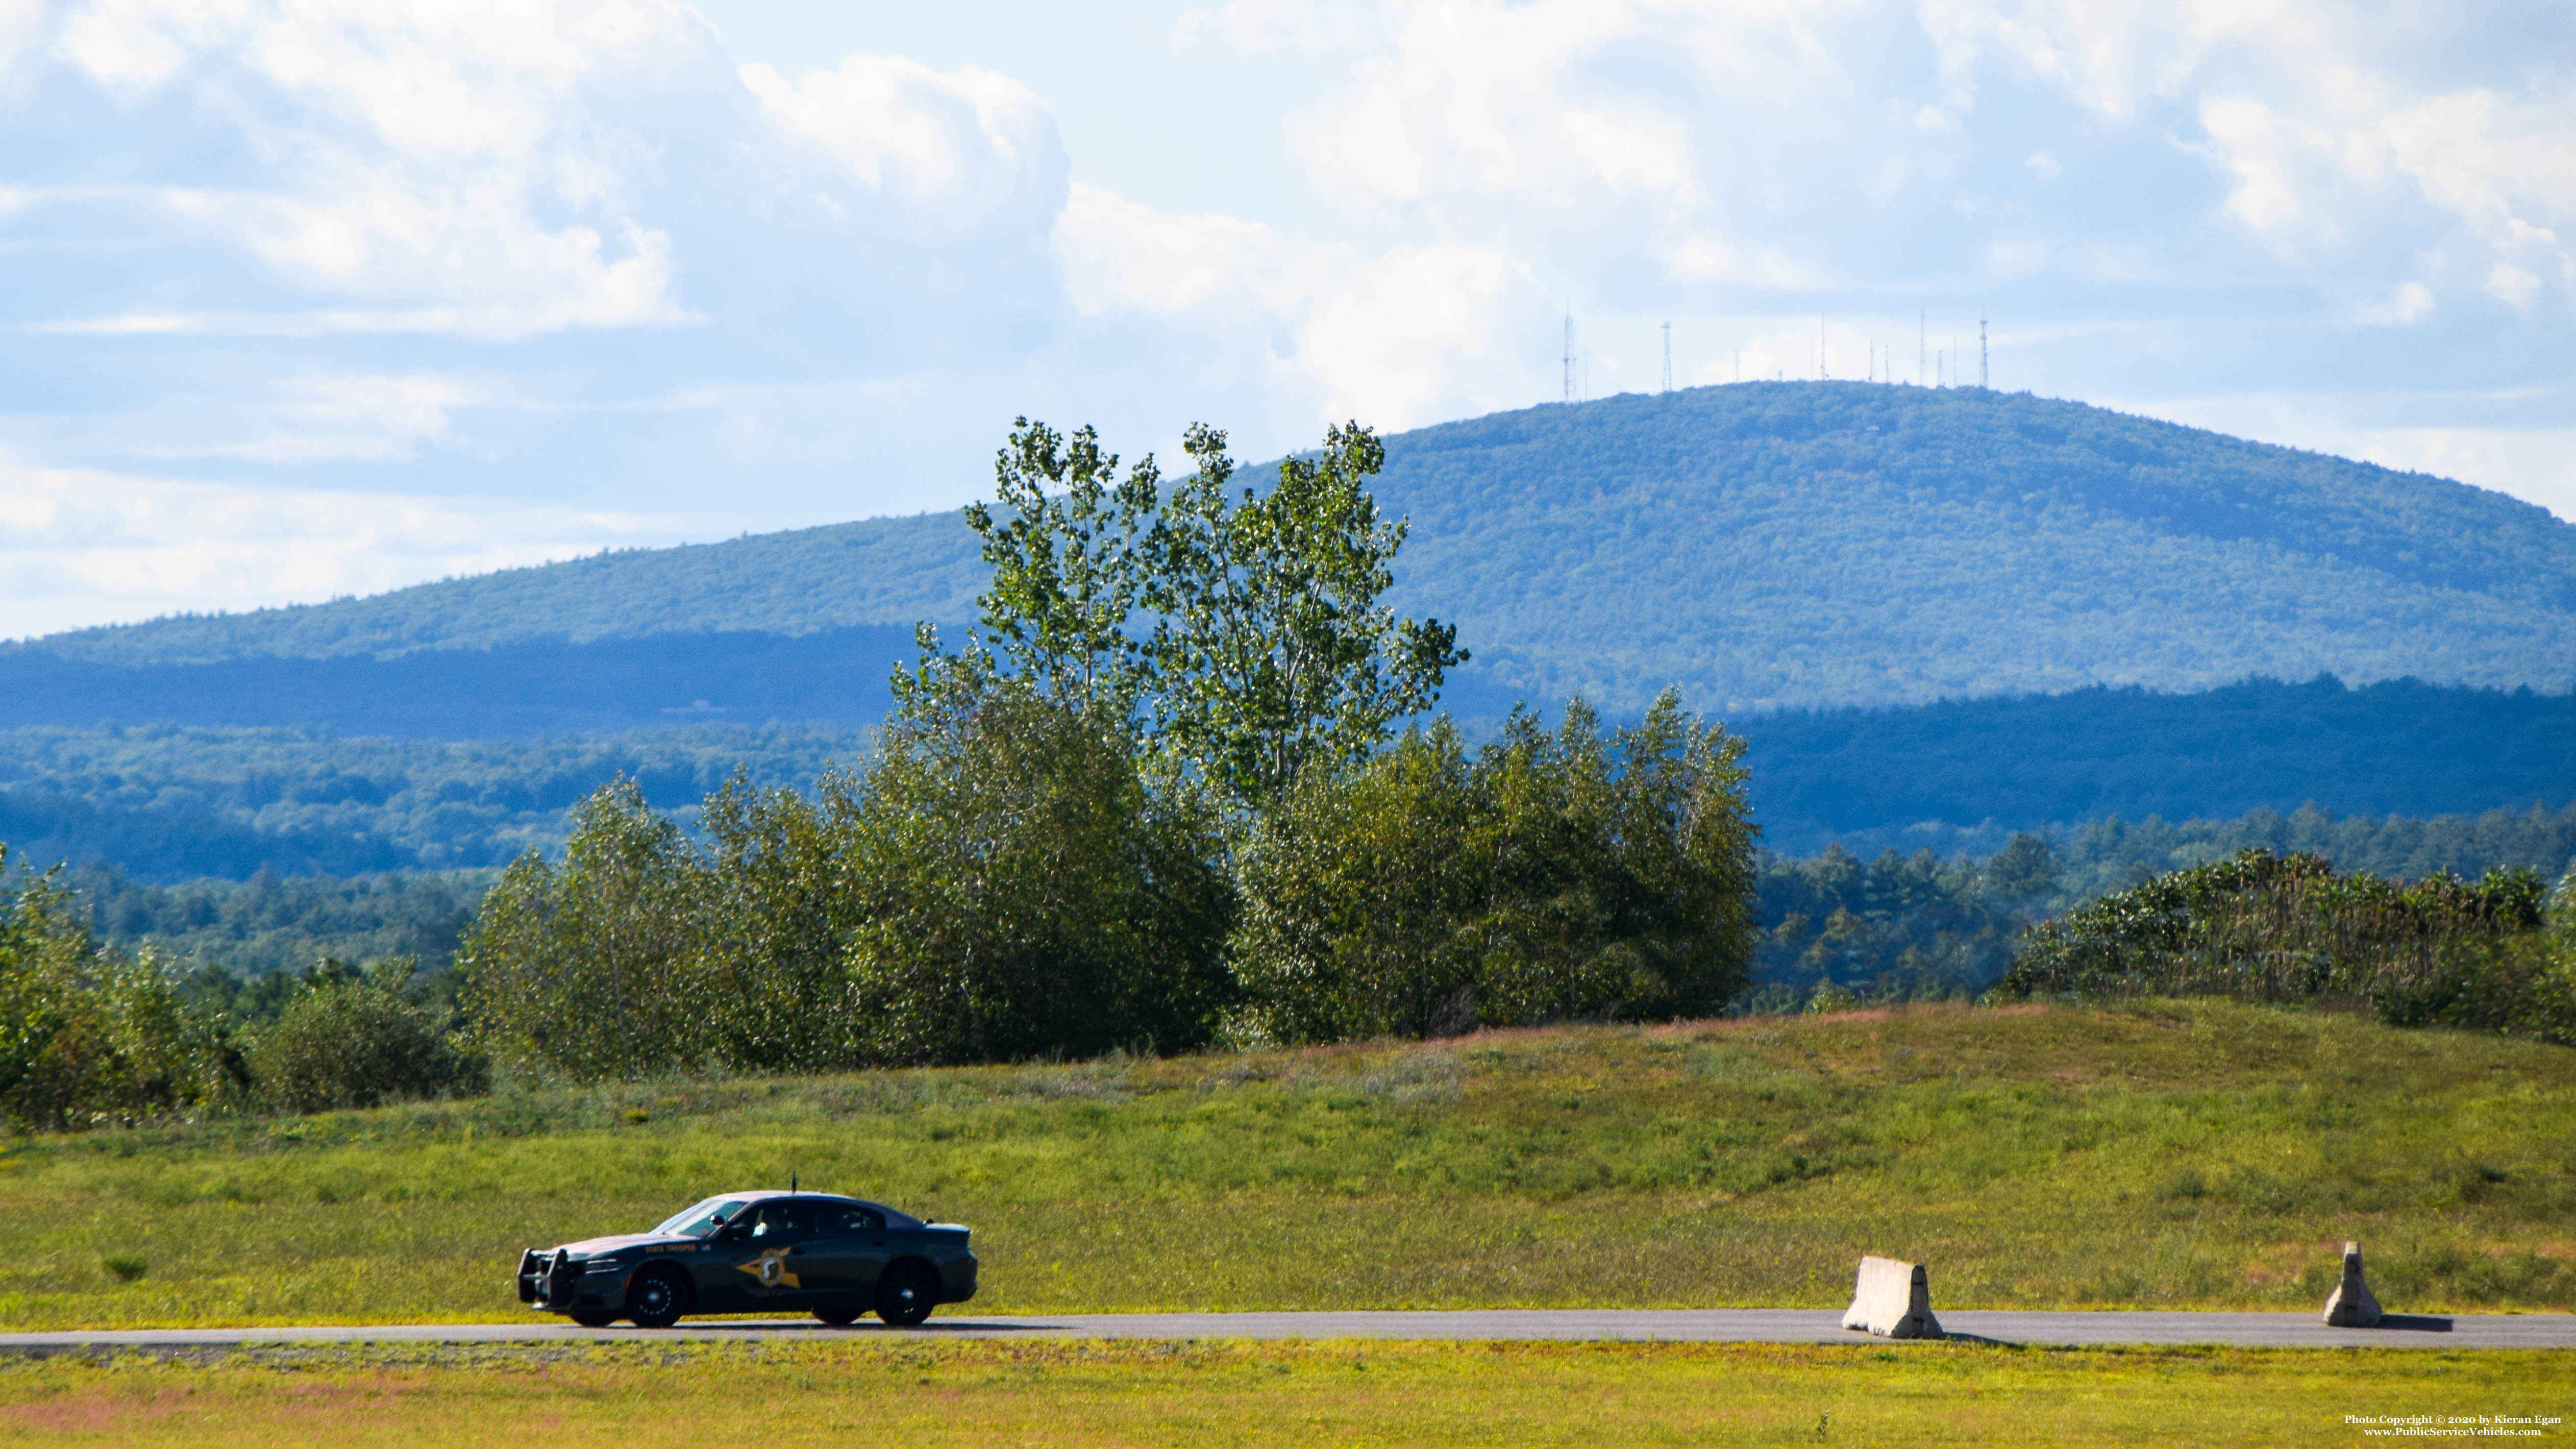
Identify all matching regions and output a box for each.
[459,420,1754,1078]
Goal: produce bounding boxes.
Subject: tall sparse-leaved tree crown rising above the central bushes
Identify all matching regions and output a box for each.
[927,417,1468,809]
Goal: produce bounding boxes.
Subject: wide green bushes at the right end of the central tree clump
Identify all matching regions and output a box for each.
[1234,694,1754,1042]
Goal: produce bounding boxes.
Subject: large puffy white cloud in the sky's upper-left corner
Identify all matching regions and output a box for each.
[39,0,721,340]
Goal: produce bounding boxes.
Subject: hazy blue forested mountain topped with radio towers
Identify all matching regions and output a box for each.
[25,382,2576,711]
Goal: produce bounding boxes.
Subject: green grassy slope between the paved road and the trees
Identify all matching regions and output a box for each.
[0,1003,2576,1328]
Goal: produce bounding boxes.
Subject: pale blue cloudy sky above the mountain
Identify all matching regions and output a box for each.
[0,0,2576,637]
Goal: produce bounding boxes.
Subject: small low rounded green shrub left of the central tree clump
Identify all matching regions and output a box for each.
[247,956,489,1111]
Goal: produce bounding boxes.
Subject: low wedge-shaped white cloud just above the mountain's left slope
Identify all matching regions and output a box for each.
[0,459,734,637]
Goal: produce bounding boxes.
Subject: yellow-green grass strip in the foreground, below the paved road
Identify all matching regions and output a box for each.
[0,1343,2576,1449]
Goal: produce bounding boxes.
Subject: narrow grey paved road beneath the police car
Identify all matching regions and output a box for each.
[0,1307,2576,1354]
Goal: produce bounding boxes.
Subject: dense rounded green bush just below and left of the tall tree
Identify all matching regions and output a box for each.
[845,670,1234,1062]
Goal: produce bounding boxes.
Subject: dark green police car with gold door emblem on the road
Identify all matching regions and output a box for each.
[518,1191,976,1328]
